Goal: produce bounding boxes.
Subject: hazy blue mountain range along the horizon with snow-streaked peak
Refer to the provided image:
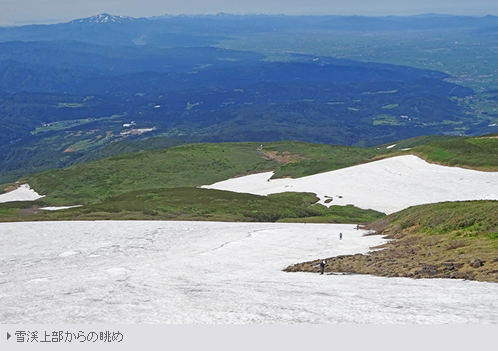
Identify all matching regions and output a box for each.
[0,13,498,46]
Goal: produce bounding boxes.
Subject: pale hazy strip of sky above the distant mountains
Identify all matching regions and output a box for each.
[0,0,498,25]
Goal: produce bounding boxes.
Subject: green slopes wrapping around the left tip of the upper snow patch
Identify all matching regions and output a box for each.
[0,142,386,223]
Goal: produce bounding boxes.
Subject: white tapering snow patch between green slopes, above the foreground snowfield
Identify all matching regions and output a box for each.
[202,155,498,214]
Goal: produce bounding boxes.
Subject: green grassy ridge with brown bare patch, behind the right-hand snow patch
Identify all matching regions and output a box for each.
[20,142,394,205]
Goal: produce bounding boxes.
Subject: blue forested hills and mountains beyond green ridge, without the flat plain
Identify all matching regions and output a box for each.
[0,14,498,180]
